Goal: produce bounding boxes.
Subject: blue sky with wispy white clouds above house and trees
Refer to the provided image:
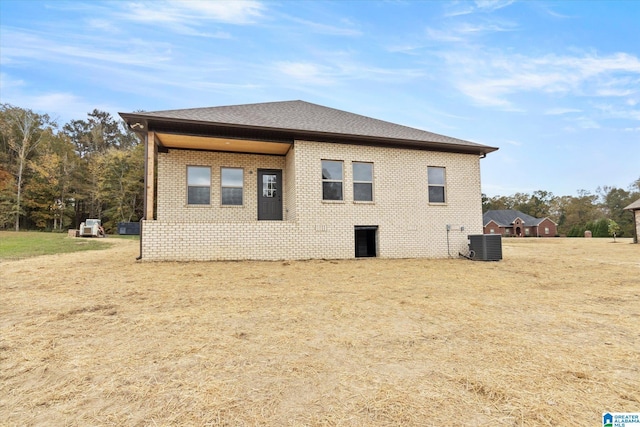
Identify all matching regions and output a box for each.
[0,0,640,196]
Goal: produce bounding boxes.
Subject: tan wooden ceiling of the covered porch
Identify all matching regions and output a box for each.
[156,133,291,156]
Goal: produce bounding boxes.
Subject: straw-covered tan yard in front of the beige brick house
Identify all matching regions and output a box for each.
[0,239,640,426]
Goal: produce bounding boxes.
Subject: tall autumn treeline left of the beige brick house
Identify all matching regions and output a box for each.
[0,104,144,232]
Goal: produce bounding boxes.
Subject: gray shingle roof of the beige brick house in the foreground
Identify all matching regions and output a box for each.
[123,101,497,153]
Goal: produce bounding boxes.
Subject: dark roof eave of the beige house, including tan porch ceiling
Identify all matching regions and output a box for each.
[119,113,498,156]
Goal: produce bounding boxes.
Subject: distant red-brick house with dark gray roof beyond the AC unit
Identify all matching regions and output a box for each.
[482,209,558,237]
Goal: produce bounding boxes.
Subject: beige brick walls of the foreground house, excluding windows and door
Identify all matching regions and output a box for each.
[143,141,482,260]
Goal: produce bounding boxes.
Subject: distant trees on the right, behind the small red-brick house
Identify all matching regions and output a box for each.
[482,184,640,237]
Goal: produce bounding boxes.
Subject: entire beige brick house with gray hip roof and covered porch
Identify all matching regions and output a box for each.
[120,101,497,260]
